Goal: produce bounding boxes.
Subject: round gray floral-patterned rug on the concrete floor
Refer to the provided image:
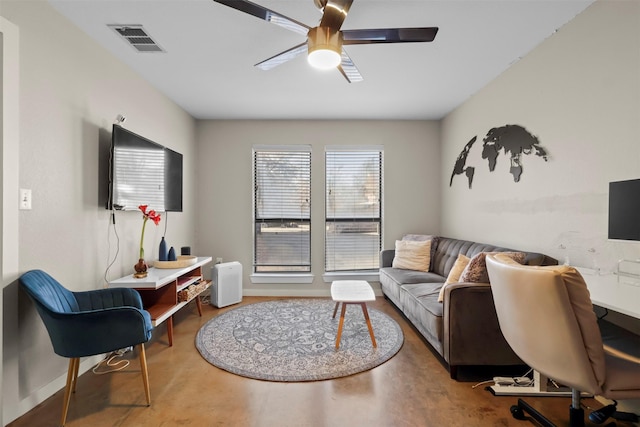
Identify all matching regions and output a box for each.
[196,299,404,382]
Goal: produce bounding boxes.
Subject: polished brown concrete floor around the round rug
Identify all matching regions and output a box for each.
[9,297,630,427]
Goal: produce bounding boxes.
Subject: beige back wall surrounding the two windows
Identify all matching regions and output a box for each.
[197,120,440,295]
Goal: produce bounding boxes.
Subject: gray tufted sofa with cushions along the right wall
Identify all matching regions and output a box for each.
[380,235,558,378]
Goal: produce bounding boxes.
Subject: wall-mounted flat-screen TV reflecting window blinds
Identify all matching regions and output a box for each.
[107,124,182,212]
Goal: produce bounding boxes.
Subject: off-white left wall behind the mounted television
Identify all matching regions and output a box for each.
[0,0,198,423]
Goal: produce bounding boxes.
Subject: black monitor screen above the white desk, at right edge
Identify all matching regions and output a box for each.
[609,179,640,241]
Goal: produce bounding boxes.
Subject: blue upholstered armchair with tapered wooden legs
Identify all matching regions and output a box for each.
[20,270,153,425]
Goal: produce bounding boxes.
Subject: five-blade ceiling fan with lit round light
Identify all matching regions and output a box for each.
[214,0,438,83]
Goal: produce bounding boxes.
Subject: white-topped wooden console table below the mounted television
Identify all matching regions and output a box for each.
[109,257,211,346]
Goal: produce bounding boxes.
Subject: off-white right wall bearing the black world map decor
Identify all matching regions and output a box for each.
[441,0,640,271]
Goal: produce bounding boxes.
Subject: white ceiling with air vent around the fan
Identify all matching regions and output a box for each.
[49,0,593,120]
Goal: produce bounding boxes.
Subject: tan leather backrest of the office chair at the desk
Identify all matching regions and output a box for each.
[487,254,605,394]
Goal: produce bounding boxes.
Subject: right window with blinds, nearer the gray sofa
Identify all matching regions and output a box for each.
[325,147,383,272]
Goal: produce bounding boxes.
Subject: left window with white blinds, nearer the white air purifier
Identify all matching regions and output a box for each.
[253,146,311,273]
